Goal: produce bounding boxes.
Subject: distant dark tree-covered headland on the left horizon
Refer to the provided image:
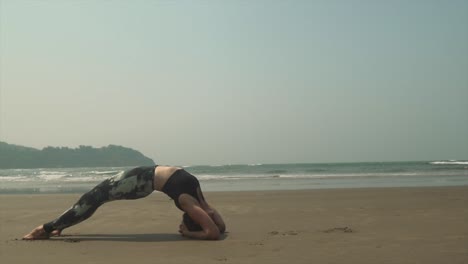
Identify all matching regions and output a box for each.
[0,142,154,169]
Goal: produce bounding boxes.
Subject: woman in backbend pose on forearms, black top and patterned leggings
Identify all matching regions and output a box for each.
[23,166,226,240]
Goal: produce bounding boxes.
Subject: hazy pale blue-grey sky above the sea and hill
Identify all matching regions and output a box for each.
[0,0,468,165]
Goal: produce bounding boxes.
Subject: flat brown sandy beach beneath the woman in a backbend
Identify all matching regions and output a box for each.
[0,187,468,264]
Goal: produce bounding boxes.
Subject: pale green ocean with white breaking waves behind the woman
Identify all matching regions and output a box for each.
[0,160,468,194]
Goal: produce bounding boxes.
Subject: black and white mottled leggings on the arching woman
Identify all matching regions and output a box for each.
[44,166,155,233]
